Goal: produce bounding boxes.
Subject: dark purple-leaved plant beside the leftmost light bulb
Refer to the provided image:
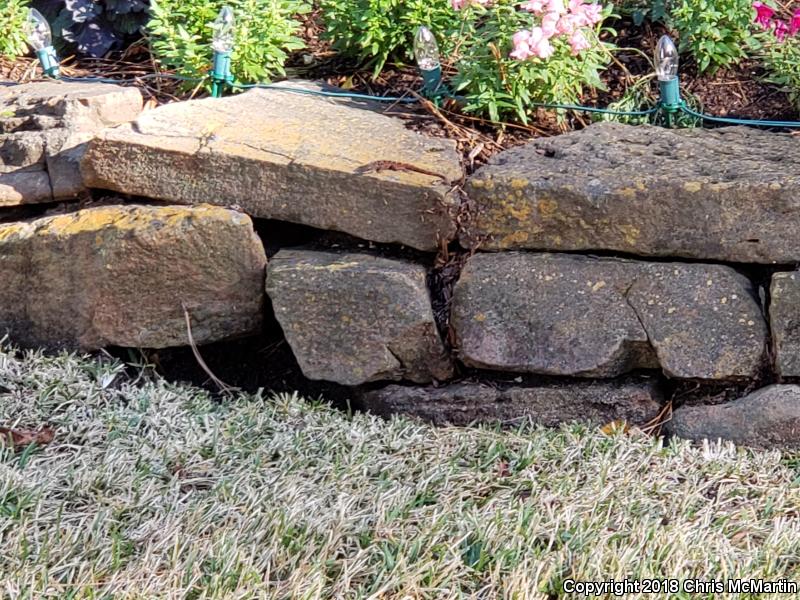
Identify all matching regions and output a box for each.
[31,0,148,57]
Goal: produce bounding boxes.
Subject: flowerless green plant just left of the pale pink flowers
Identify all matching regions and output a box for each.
[320,0,461,75]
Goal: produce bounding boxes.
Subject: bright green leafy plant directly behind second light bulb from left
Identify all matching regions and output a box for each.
[147,0,309,82]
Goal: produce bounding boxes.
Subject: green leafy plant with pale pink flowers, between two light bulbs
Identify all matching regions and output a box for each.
[454,0,613,122]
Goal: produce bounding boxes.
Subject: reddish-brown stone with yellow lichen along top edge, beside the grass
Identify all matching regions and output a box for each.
[0,206,266,350]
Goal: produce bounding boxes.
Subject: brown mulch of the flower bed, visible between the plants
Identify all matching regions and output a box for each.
[0,13,798,172]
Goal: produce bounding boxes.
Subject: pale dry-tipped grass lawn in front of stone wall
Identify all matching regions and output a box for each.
[0,352,800,599]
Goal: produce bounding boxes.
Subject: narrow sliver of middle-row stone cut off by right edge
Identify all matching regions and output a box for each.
[769,271,800,377]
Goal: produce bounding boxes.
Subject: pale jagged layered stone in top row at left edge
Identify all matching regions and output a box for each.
[0,81,142,207]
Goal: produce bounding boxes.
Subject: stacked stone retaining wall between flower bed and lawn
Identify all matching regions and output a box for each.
[0,83,800,446]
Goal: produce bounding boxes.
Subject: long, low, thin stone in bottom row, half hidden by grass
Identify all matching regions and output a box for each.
[360,379,663,427]
